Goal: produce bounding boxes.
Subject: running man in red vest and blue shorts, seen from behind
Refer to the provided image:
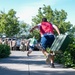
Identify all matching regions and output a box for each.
[30,18,60,68]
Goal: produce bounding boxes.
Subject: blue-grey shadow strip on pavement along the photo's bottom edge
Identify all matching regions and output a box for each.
[0,67,75,75]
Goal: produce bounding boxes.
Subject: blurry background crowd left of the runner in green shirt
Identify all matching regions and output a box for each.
[0,38,28,51]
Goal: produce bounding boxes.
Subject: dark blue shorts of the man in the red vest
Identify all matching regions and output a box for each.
[40,35,55,50]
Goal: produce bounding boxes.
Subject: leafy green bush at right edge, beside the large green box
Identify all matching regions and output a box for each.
[55,35,75,67]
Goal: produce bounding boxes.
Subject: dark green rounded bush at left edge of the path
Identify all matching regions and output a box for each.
[0,44,10,58]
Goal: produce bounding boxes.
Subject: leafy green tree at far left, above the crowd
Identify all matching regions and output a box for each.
[0,9,20,37]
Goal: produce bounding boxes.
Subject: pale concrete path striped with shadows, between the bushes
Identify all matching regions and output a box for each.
[0,51,75,75]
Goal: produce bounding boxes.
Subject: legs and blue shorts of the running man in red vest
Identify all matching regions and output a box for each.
[41,36,54,68]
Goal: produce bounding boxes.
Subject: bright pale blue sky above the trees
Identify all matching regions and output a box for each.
[0,0,75,25]
